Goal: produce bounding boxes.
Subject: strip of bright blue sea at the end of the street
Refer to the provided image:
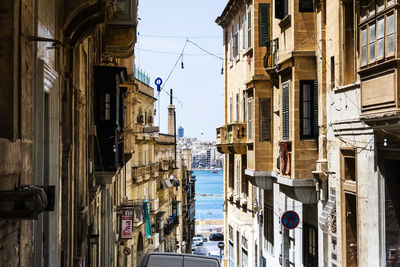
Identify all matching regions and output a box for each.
[193,170,224,220]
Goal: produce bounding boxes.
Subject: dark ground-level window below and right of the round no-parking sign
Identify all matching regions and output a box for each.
[303,223,318,267]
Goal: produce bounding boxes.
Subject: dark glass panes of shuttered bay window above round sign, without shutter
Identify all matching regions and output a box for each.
[300,81,313,138]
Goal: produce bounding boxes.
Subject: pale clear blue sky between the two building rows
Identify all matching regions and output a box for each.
[135,0,226,140]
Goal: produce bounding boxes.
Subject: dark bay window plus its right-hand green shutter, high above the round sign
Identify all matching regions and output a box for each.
[300,81,318,139]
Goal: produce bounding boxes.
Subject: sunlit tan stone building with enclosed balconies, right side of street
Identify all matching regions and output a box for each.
[217,0,400,266]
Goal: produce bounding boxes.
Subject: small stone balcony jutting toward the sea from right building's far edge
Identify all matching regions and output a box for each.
[217,123,247,154]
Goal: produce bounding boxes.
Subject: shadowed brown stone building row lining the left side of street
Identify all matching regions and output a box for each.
[0,0,186,266]
